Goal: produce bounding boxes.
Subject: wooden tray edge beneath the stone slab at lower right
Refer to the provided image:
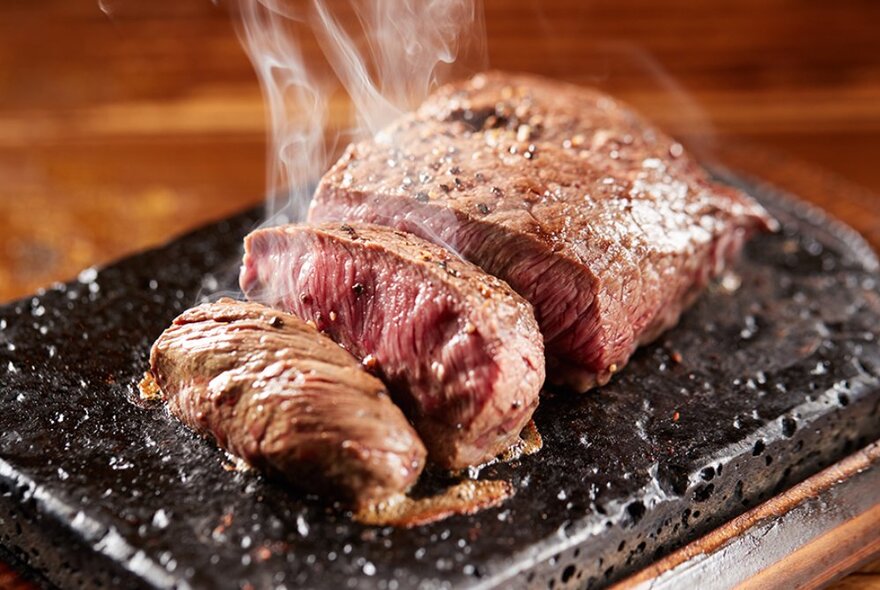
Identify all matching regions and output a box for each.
[612,441,880,590]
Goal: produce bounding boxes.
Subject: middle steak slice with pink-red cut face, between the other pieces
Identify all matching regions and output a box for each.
[241,223,544,469]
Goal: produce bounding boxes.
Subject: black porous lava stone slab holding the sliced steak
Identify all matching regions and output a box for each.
[0,172,880,589]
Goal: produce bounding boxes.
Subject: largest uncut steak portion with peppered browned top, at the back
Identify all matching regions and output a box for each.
[309,73,773,390]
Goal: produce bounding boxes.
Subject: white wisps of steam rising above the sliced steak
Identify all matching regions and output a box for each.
[239,0,486,223]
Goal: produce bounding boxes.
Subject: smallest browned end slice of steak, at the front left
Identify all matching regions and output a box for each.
[150,299,426,506]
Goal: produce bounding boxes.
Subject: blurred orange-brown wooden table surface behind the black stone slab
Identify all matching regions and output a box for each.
[0,0,880,588]
